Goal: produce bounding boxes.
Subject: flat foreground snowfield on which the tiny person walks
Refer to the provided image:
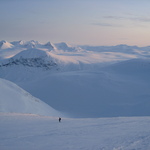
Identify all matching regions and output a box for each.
[0,113,150,150]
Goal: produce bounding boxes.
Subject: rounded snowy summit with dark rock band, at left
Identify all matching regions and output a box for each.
[0,48,56,70]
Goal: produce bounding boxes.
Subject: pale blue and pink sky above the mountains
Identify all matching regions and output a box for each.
[0,0,150,46]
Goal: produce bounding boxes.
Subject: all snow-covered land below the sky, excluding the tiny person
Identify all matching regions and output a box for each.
[0,40,150,150]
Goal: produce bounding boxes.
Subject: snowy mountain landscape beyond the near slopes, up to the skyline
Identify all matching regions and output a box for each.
[0,41,150,117]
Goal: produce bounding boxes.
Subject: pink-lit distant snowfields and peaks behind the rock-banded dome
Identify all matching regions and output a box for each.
[1,40,145,65]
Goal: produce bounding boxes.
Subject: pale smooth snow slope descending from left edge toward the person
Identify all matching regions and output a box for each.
[0,79,63,116]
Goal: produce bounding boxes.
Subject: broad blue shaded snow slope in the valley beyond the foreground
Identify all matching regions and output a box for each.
[17,59,150,117]
